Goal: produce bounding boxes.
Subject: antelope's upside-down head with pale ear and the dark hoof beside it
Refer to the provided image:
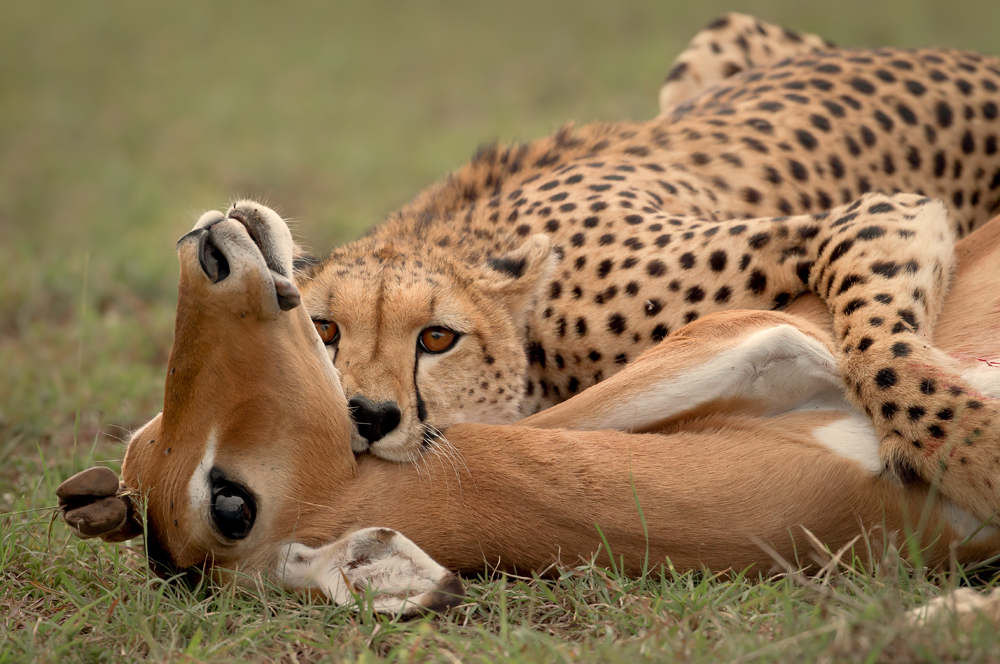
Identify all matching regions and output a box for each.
[59,201,461,614]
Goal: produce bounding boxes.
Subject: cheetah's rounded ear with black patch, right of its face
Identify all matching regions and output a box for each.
[479,234,559,326]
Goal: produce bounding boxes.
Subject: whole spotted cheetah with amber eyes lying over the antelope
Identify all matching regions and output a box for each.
[300,15,1000,516]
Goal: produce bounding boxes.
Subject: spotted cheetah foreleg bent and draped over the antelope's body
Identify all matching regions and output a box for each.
[802,195,1000,519]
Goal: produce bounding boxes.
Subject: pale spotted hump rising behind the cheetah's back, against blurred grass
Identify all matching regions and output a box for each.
[660,12,833,116]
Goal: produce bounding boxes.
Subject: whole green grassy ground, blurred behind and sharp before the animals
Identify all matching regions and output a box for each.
[0,0,1000,662]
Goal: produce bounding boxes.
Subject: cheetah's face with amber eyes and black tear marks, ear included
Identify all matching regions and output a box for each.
[300,235,555,462]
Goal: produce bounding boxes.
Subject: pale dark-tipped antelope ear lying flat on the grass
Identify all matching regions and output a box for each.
[274,528,465,617]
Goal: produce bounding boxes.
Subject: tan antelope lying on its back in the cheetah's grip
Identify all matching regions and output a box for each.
[60,202,1000,614]
